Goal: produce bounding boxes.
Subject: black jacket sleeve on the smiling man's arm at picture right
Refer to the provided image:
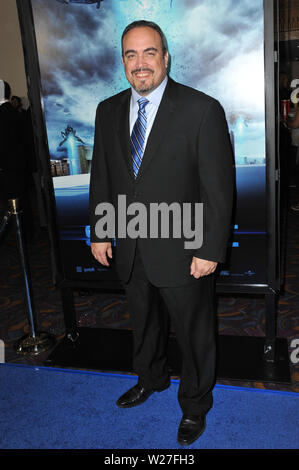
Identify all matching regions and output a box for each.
[194,100,235,262]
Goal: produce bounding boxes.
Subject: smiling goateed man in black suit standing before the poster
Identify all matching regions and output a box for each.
[90,21,233,445]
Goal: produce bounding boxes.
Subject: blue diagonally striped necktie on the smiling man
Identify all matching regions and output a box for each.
[130,98,149,178]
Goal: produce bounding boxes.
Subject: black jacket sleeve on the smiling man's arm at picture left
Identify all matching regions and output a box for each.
[89,103,112,243]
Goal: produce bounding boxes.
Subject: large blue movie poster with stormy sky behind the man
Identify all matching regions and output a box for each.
[32,0,266,284]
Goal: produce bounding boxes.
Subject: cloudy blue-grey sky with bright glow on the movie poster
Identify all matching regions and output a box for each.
[32,0,264,156]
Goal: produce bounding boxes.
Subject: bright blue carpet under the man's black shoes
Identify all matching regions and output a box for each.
[0,364,299,449]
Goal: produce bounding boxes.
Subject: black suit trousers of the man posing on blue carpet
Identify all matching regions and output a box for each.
[125,246,216,415]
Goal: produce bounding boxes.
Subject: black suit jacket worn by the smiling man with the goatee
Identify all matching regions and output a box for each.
[90,78,234,287]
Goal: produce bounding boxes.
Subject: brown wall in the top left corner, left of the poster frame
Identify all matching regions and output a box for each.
[0,0,27,107]
